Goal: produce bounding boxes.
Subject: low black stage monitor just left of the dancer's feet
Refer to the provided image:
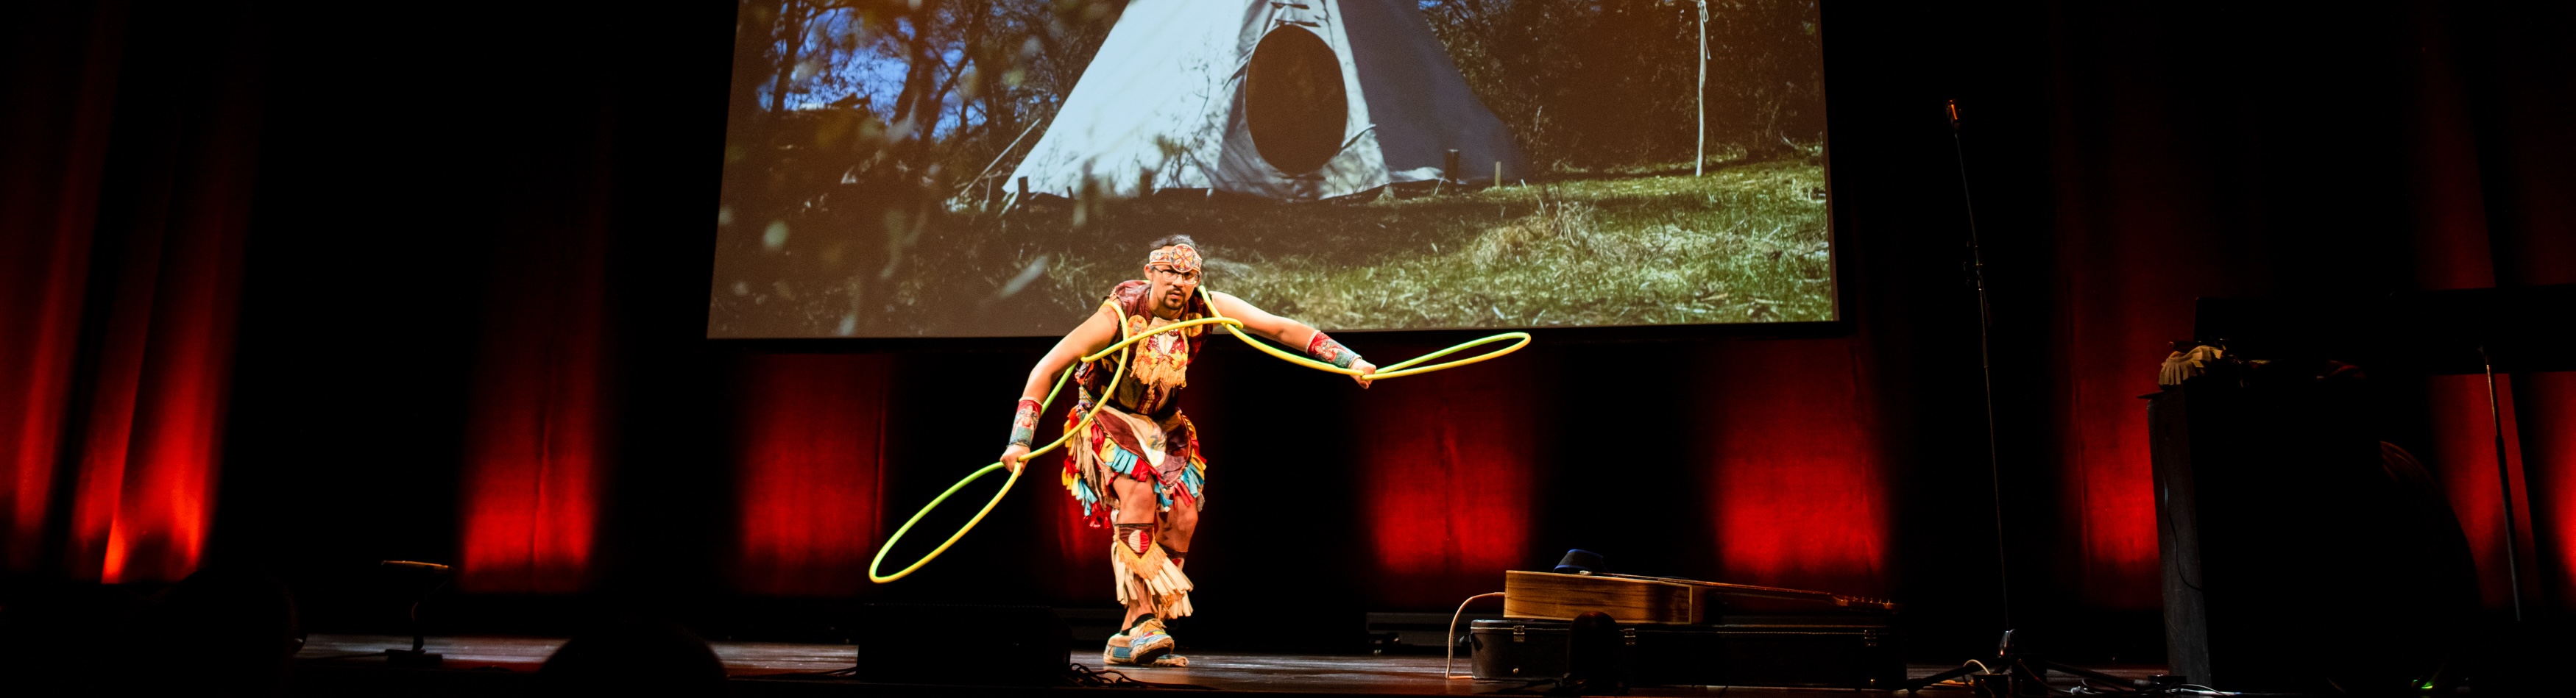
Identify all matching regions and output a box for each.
[858,602,1075,685]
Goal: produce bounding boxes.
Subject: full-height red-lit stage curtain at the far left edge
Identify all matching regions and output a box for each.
[0,5,263,582]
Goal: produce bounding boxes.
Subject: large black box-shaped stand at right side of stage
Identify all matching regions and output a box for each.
[2146,355,2478,693]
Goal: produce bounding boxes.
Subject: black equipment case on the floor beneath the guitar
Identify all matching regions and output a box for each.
[1468,616,1906,688]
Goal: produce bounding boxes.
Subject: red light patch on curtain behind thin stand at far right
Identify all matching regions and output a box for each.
[2427,376,2538,608]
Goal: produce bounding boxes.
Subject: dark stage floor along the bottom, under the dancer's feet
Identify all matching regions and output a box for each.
[297,636,2164,698]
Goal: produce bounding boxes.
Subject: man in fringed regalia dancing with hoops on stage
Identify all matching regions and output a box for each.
[1002,235,1379,667]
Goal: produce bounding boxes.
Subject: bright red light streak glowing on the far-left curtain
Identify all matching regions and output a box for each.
[55,57,258,585]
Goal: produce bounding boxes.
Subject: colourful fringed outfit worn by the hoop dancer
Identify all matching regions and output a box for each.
[1064,281,1209,618]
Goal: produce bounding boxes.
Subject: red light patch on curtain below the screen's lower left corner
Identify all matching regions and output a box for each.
[735,353,891,595]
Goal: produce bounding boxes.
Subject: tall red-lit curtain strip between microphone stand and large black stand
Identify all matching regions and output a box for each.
[2045,65,2229,610]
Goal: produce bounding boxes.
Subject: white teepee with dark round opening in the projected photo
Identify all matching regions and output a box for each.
[1005,0,1523,201]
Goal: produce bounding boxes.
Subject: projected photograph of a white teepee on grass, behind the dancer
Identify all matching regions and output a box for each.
[709,0,1837,338]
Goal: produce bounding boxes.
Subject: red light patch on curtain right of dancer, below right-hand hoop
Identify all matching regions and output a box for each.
[1353,366,1538,608]
